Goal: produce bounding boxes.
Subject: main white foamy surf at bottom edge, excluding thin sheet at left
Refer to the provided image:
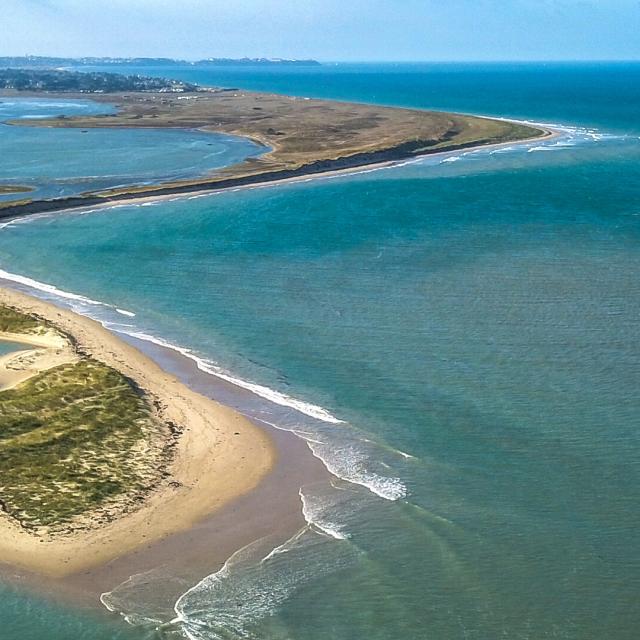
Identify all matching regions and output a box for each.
[171,483,358,640]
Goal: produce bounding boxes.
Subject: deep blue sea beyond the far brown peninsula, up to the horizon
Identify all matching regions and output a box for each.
[87,62,640,132]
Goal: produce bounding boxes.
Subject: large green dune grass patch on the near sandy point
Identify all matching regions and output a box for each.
[0,359,166,531]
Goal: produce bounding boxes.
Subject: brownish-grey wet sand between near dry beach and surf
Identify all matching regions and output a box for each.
[0,288,330,611]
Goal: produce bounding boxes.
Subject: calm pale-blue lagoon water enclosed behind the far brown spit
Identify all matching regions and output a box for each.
[0,98,264,201]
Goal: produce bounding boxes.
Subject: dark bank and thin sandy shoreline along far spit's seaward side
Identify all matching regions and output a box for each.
[0,123,561,220]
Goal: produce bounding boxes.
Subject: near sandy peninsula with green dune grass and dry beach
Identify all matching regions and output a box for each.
[0,289,274,577]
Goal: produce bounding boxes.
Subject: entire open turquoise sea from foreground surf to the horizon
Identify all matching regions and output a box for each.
[0,65,640,640]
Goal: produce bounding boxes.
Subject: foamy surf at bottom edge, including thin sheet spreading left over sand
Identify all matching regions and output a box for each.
[101,481,362,640]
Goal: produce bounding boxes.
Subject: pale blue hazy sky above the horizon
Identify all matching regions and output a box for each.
[0,0,640,61]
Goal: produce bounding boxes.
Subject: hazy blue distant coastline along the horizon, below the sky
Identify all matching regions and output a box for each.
[0,56,320,68]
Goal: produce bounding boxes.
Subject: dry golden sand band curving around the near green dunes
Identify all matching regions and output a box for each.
[0,288,276,578]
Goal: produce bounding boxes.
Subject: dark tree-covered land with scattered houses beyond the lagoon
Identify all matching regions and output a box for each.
[0,69,199,93]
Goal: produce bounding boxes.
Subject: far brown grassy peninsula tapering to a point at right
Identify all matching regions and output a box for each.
[0,72,551,217]
